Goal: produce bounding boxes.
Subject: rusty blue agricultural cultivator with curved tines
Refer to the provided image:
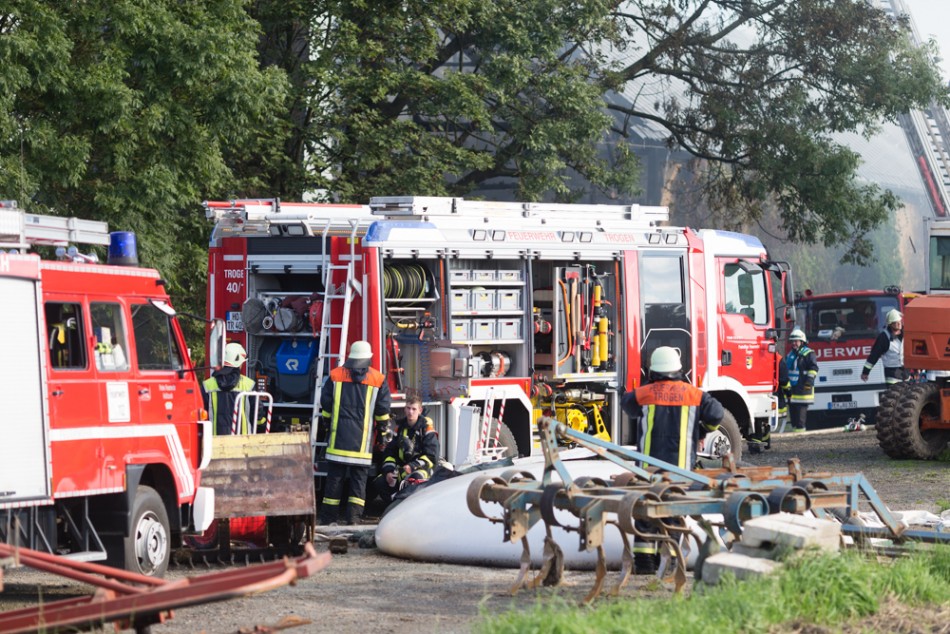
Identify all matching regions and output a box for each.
[467,418,950,602]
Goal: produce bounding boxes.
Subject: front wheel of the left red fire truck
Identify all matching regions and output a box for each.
[124,485,171,577]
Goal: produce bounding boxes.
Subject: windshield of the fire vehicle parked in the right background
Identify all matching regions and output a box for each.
[796,295,898,341]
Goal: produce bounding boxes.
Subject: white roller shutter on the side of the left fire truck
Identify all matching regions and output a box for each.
[0,264,50,503]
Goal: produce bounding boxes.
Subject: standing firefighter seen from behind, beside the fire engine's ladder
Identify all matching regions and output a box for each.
[317,341,390,524]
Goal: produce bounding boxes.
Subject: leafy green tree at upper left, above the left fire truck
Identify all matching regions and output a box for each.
[0,0,286,326]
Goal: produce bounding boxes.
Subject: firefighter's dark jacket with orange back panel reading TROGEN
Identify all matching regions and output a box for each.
[620,379,723,469]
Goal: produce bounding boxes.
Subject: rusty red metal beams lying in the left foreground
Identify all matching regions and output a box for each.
[0,544,331,633]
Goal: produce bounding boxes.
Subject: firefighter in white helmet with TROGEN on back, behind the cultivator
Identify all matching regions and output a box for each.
[620,346,725,574]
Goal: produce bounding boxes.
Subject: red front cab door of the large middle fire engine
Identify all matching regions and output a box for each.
[716,258,775,391]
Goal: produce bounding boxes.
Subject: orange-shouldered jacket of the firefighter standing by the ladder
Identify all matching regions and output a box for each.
[320,366,390,466]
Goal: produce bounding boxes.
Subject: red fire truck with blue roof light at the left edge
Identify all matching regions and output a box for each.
[0,202,218,575]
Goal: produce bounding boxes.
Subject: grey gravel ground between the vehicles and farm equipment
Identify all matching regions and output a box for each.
[0,430,950,634]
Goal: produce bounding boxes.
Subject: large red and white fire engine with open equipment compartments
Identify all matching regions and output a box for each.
[205,197,793,473]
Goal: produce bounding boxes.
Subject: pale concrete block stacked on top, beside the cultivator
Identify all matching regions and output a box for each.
[741,513,841,552]
